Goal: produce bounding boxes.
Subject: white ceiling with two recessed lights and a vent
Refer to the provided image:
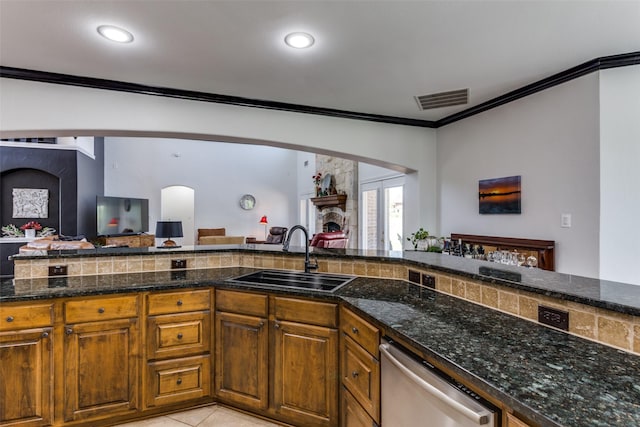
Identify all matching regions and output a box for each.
[0,0,640,120]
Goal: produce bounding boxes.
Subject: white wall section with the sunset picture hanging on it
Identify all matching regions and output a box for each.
[437,73,600,277]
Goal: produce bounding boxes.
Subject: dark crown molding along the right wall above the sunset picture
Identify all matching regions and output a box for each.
[435,52,640,128]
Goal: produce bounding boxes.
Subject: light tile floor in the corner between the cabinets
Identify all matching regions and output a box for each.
[113,405,279,427]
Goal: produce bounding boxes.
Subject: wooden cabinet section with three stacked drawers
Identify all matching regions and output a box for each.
[143,289,211,408]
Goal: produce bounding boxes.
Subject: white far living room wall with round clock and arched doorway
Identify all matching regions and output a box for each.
[105,137,298,242]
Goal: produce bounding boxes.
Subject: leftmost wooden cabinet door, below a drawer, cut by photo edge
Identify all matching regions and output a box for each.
[0,328,53,427]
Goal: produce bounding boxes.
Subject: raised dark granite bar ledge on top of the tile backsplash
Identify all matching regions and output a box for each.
[8,244,640,316]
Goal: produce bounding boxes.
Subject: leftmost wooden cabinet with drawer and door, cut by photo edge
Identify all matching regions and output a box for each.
[0,304,53,427]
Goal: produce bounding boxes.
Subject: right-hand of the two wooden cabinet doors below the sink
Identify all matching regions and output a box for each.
[273,320,339,426]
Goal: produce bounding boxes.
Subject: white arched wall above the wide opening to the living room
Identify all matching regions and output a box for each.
[0,78,436,237]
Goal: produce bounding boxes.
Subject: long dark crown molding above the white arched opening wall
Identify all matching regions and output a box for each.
[0,66,435,128]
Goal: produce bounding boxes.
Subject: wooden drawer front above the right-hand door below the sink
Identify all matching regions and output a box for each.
[274,297,338,328]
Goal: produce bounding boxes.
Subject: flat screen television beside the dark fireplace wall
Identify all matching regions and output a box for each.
[96,196,149,236]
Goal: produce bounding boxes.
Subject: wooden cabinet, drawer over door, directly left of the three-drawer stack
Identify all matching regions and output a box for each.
[61,295,139,421]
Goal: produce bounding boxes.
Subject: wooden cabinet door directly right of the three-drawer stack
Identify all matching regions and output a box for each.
[215,312,269,410]
